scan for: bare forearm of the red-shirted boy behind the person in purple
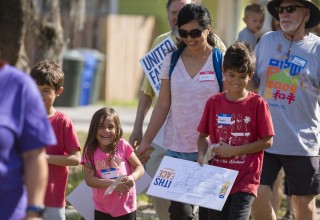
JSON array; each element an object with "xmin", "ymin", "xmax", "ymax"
[{"xmin": 47, "ymin": 148, "xmax": 81, "ymax": 166}]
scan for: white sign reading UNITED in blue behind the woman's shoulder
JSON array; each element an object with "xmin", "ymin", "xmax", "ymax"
[{"xmin": 140, "ymin": 36, "xmax": 177, "ymax": 96}]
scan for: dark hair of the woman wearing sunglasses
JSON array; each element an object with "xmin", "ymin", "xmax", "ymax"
[{"xmin": 177, "ymin": 3, "xmax": 215, "ymax": 47}]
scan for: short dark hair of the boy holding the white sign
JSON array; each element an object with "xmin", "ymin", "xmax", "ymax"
[{"xmin": 223, "ymin": 42, "xmax": 256, "ymax": 76}]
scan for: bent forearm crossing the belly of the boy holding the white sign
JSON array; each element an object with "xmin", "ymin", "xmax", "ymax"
[{"xmin": 213, "ymin": 136, "xmax": 273, "ymax": 157}]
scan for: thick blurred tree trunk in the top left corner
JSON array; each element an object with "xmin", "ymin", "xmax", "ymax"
[{"xmin": 0, "ymin": 0, "xmax": 85, "ymax": 72}]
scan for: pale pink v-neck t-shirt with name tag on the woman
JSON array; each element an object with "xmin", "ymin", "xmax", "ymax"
[{"xmin": 160, "ymin": 53, "xmax": 220, "ymax": 153}]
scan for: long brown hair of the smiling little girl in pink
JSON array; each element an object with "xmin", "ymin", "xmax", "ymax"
[{"xmin": 82, "ymin": 107, "xmax": 123, "ymax": 175}]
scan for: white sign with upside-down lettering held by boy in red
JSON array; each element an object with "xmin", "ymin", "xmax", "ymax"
[{"xmin": 147, "ymin": 156, "xmax": 238, "ymax": 211}]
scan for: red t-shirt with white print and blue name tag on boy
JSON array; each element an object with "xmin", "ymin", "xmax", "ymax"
[{"xmin": 198, "ymin": 92, "xmax": 274, "ymax": 196}]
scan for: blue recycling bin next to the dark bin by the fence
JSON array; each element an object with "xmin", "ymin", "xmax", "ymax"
[{"xmin": 77, "ymin": 48, "xmax": 105, "ymax": 105}]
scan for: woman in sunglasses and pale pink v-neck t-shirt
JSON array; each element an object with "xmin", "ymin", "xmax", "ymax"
[{"xmin": 137, "ymin": 4, "xmax": 225, "ymax": 220}]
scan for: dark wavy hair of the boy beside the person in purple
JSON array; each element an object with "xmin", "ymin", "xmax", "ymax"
[{"xmin": 30, "ymin": 59, "xmax": 64, "ymax": 92}]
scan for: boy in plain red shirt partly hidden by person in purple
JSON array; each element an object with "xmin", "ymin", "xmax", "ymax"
[{"xmin": 30, "ymin": 60, "xmax": 81, "ymax": 220}]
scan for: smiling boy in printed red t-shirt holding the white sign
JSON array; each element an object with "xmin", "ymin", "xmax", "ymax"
[{"xmin": 198, "ymin": 42, "xmax": 274, "ymax": 220}]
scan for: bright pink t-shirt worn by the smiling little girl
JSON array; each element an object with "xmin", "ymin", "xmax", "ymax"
[{"xmin": 81, "ymin": 139, "xmax": 137, "ymax": 217}]
